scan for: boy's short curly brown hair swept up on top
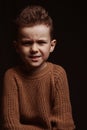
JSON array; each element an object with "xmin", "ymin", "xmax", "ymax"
[{"xmin": 15, "ymin": 5, "xmax": 53, "ymax": 39}]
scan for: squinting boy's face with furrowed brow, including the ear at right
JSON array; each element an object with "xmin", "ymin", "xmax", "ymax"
[{"xmin": 16, "ymin": 24, "xmax": 56, "ymax": 68}]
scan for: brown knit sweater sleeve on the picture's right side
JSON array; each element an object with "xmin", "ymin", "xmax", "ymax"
[{"xmin": 51, "ymin": 66, "xmax": 75, "ymax": 130}]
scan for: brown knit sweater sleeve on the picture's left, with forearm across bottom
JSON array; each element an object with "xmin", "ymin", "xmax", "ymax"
[{"xmin": 0, "ymin": 70, "xmax": 42, "ymax": 130}]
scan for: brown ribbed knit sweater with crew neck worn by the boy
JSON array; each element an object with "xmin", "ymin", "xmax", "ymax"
[{"xmin": 2, "ymin": 62, "xmax": 75, "ymax": 130}]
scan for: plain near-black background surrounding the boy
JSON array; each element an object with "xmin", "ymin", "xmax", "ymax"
[{"xmin": 0, "ymin": 0, "xmax": 87, "ymax": 130}]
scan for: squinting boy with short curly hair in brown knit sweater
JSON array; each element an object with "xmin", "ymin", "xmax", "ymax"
[{"xmin": 2, "ymin": 6, "xmax": 75, "ymax": 130}]
